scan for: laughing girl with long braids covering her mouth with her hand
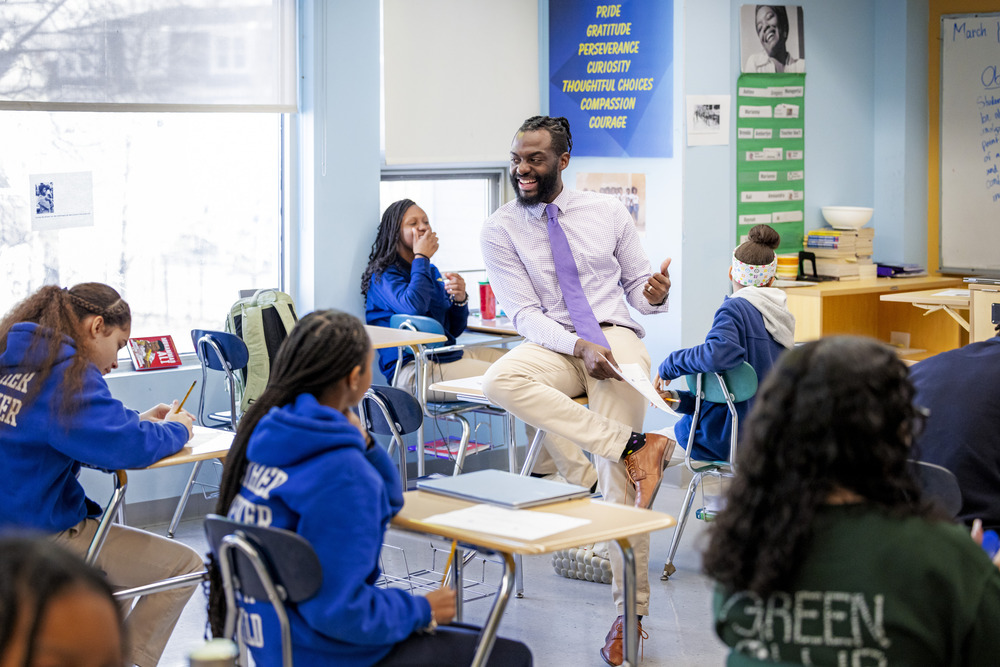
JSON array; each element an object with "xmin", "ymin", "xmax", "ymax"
[{"xmin": 361, "ymin": 199, "xmax": 506, "ymax": 401}]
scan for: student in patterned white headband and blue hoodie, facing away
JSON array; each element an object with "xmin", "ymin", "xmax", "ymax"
[{"xmin": 656, "ymin": 225, "xmax": 795, "ymax": 461}]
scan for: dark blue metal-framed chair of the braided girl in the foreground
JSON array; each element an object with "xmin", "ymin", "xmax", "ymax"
[{"xmin": 205, "ymin": 514, "xmax": 323, "ymax": 667}]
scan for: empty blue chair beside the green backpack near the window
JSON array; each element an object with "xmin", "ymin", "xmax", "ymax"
[{"xmin": 167, "ymin": 329, "xmax": 250, "ymax": 537}]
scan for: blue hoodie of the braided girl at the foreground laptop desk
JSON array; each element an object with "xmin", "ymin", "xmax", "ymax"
[{"xmin": 229, "ymin": 394, "xmax": 431, "ymax": 667}]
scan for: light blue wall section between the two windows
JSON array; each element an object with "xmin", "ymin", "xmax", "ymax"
[{"xmin": 293, "ymin": 0, "xmax": 381, "ymax": 317}]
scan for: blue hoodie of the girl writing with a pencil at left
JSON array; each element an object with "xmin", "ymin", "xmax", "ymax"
[{"xmin": 0, "ymin": 322, "xmax": 188, "ymax": 533}]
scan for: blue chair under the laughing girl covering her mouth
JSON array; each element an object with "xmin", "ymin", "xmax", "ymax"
[{"xmin": 389, "ymin": 315, "xmax": 505, "ymax": 475}]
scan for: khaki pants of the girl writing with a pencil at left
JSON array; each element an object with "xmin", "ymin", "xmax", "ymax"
[{"xmin": 53, "ymin": 519, "xmax": 205, "ymax": 667}]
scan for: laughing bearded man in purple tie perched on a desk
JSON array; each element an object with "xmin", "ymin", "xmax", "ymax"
[{"xmin": 481, "ymin": 116, "xmax": 675, "ymax": 665}]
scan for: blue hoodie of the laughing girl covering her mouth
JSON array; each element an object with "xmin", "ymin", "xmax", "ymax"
[{"xmin": 365, "ymin": 257, "xmax": 469, "ymax": 384}]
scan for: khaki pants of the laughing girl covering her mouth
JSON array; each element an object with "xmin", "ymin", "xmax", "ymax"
[{"xmin": 393, "ymin": 347, "xmax": 597, "ymax": 489}]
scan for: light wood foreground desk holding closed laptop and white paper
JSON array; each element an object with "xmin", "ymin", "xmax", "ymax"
[{"xmin": 392, "ymin": 491, "xmax": 676, "ymax": 667}]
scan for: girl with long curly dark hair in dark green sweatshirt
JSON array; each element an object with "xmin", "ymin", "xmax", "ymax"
[{"xmin": 703, "ymin": 336, "xmax": 1000, "ymax": 667}]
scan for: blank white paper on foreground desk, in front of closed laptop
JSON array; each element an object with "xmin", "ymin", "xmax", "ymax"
[{"xmin": 422, "ymin": 503, "xmax": 590, "ymax": 540}]
